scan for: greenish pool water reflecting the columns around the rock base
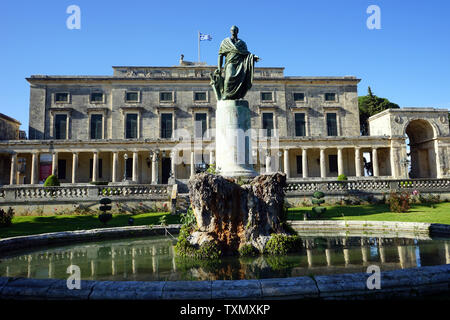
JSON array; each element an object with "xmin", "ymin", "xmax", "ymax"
[{"xmin": 0, "ymin": 236, "xmax": 450, "ymax": 281}]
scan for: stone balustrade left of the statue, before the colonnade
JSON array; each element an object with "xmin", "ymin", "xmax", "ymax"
[{"xmin": 0, "ymin": 184, "xmax": 172, "ymax": 204}]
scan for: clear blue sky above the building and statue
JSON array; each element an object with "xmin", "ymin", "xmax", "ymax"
[{"xmin": 0, "ymin": 0, "xmax": 450, "ymax": 131}]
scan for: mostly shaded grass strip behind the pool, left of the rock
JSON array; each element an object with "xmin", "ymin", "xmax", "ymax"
[{"xmin": 0, "ymin": 212, "xmax": 179, "ymax": 238}]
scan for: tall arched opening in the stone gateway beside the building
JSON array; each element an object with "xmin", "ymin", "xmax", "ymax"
[{"xmin": 404, "ymin": 119, "xmax": 438, "ymax": 178}]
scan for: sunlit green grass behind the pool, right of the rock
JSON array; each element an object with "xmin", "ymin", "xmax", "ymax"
[{"xmin": 288, "ymin": 202, "xmax": 450, "ymax": 224}]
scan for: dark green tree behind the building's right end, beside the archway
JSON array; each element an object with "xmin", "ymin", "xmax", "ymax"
[{"xmin": 358, "ymin": 87, "xmax": 400, "ymax": 136}]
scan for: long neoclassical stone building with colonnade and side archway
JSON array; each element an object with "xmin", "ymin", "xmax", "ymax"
[{"xmin": 0, "ymin": 64, "xmax": 450, "ymax": 184}]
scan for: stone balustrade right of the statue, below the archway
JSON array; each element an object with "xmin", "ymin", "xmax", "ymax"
[{"xmin": 285, "ymin": 179, "xmax": 450, "ymax": 195}]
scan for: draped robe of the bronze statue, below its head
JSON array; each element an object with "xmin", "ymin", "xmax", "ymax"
[{"xmin": 211, "ymin": 38, "xmax": 255, "ymax": 100}]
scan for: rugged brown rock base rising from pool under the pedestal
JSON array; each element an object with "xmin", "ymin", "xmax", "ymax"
[{"xmin": 188, "ymin": 173, "xmax": 286, "ymax": 255}]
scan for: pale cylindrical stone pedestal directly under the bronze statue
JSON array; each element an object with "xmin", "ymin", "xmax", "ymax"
[{"xmin": 216, "ymin": 100, "xmax": 257, "ymax": 177}]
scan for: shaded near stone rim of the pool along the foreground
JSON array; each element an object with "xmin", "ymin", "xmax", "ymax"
[{"xmin": 0, "ymin": 264, "xmax": 450, "ymax": 300}]
